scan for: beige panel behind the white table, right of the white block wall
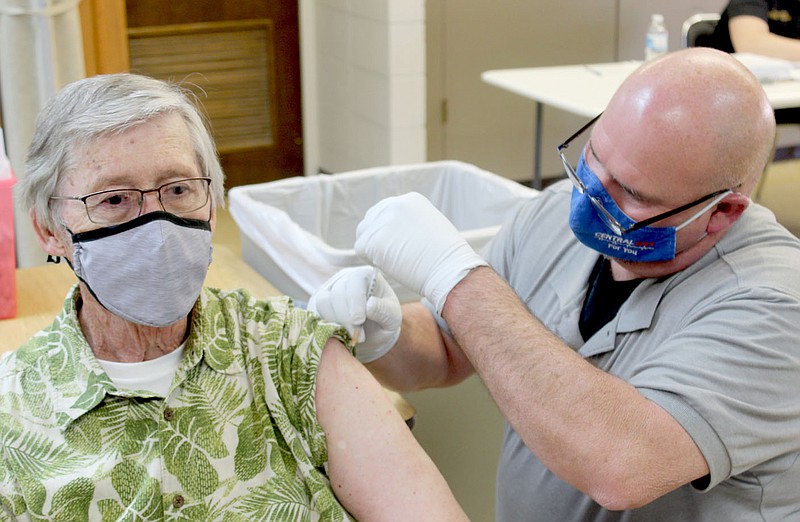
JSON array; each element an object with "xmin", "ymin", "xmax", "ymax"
[{"xmin": 426, "ymin": 0, "xmax": 617, "ymax": 181}]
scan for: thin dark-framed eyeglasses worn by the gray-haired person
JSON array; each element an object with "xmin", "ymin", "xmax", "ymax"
[{"xmin": 50, "ymin": 178, "xmax": 211, "ymax": 225}]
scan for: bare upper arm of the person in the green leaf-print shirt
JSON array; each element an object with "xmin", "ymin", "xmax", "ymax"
[{"xmin": 316, "ymin": 339, "xmax": 468, "ymax": 521}]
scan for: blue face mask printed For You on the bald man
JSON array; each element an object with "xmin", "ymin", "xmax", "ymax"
[{"xmin": 569, "ymin": 154, "xmax": 731, "ymax": 263}]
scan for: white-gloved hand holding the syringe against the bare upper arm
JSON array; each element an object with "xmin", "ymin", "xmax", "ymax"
[{"xmin": 308, "ymin": 266, "xmax": 403, "ymax": 363}]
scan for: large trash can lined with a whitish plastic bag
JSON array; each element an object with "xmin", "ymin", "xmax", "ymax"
[{"xmin": 228, "ymin": 161, "xmax": 538, "ymax": 304}]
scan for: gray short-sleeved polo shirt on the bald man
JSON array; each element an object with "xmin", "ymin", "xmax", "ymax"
[{"xmin": 487, "ymin": 182, "xmax": 800, "ymax": 522}]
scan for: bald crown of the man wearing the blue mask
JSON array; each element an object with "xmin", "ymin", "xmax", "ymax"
[{"xmin": 593, "ymin": 48, "xmax": 775, "ymax": 195}]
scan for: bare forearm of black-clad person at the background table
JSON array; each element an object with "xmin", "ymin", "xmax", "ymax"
[{"xmin": 728, "ymin": 15, "xmax": 800, "ymax": 62}]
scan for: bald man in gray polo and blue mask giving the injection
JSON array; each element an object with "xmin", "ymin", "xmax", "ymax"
[{"xmin": 312, "ymin": 48, "xmax": 800, "ymax": 522}]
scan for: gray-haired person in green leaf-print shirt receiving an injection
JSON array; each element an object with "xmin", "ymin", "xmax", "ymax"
[{"xmin": 0, "ymin": 74, "xmax": 465, "ymax": 521}]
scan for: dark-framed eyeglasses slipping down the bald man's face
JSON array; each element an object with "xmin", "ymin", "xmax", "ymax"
[{"xmin": 558, "ymin": 112, "xmax": 733, "ymax": 236}]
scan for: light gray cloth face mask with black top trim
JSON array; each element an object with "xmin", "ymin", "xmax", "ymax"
[{"xmin": 67, "ymin": 212, "xmax": 212, "ymax": 327}]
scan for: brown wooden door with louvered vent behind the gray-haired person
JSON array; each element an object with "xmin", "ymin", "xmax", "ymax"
[{"xmin": 125, "ymin": 0, "xmax": 303, "ymax": 187}]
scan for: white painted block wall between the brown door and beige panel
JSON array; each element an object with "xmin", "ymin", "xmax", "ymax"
[{"xmin": 310, "ymin": 0, "xmax": 426, "ymax": 172}]
